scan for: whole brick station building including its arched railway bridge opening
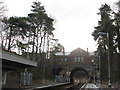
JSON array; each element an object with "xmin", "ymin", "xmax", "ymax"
[{"xmin": 55, "ymin": 48, "xmax": 98, "ymax": 82}]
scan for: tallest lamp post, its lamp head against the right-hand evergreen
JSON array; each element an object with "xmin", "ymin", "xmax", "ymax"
[{"xmin": 98, "ymin": 32, "xmax": 111, "ymax": 87}]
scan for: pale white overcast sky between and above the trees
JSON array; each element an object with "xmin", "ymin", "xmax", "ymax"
[{"xmin": 4, "ymin": 0, "xmax": 117, "ymax": 52}]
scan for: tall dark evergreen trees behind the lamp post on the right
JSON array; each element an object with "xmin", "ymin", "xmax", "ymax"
[{"xmin": 92, "ymin": 4, "xmax": 120, "ymax": 81}]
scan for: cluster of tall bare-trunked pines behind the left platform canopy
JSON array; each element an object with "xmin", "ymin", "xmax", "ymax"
[{"xmin": 2, "ymin": 1, "xmax": 63, "ymax": 60}]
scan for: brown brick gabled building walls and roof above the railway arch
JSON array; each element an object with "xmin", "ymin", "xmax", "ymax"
[{"xmin": 55, "ymin": 48, "xmax": 98, "ymax": 77}]
